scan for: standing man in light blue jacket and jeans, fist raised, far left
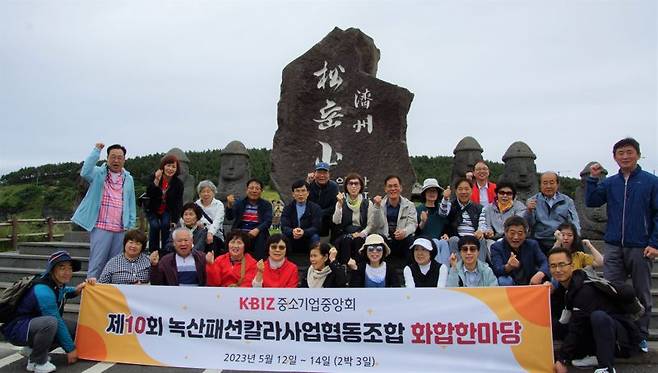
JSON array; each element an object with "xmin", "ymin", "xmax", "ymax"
[{"xmin": 71, "ymin": 143, "xmax": 137, "ymax": 278}]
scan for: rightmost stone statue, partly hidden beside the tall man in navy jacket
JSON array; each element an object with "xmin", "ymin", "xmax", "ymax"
[{"xmin": 574, "ymin": 161, "xmax": 608, "ymax": 240}]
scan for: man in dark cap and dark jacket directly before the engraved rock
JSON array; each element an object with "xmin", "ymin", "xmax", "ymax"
[{"xmin": 306, "ymin": 162, "xmax": 340, "ymax": 236}]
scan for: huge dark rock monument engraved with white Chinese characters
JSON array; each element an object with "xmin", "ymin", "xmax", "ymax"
[{"xmin": 271, "ymin": 28, "xmax": 415, "ymax": 200}]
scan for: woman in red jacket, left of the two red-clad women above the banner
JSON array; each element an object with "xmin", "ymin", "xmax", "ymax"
[{"xmin": 206, "ymin": 230, "xmax": 256, "ymax": 288}]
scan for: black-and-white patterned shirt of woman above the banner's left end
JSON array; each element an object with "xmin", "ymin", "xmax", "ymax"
[{"xmin": 98, "ymin": 254, "xmax": 151, "ymax": 285}]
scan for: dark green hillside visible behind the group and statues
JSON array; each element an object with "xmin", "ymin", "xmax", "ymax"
[{"xmin": 0, "ymin": 149, "xmax": 578, "ymax": 221}]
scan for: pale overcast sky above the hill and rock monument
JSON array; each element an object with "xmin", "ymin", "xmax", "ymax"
[{"xmin": 0, "ymin": 0, "xmax": 658, "ymax": 176}]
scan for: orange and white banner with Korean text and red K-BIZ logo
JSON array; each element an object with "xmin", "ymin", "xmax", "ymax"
[{"xmin": 76, "ymin": 285, "xmax": 553, "ymax": 372}]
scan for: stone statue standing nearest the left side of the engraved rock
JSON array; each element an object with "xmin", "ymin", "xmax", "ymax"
[{"xmin": 216, "ymin": 141, "xmax": 251, "ymax": 203}]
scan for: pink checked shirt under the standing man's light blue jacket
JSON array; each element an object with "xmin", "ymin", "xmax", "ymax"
[{"xmin": 96, "ymin": 172, "xmax": 123, "ymax": 232}]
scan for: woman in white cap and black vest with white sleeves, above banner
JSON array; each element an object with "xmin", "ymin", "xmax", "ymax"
[{"xmin": 403, "ymin": 237, "xmax": 448, "ymax": 288}]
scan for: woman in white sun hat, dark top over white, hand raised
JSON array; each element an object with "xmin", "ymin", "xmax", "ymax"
[{"xmin": 347, "ymin": 234, "xmax": 400, "ymax": 288}]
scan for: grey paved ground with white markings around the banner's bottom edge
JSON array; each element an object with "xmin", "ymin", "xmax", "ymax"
[{"xmin": 0, "ymin": 342, "xmax": 658, "ymax": 373}]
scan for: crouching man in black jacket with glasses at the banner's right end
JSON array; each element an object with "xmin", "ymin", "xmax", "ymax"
[{"xmin": 548, "ymin": 248, "xmax": 640, "ymax": 373}]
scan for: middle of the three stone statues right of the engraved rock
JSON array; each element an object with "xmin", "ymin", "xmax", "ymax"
[{"xmin": 498, "ymin": 141, "xmax": 539, "ymax": 204}]
